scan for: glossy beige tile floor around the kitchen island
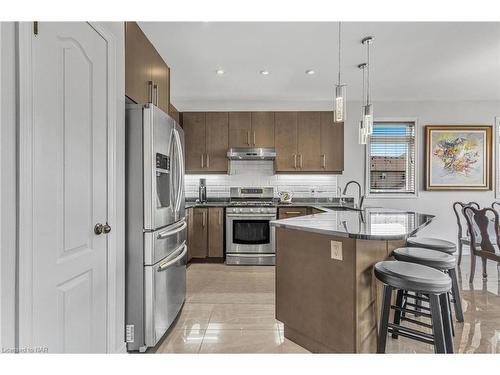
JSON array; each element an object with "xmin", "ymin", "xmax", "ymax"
[{"xmin": 152, "ymin": 257, "xmax": 500, "ymax": 353}]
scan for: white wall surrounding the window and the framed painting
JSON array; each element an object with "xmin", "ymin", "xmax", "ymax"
[{"xmin": 339, "ymin": 101, "xmax": 500, "ymax": 247}]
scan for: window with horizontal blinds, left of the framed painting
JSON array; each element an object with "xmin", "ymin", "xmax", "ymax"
[{"xmin": 367, "ymin": 121, "xmax": 416, "ymax": 197}]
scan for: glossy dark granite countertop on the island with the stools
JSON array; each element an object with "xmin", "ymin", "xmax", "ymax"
[{"xmin": 271, "ymin": 209, "xmax": 434, "ymax": 240}]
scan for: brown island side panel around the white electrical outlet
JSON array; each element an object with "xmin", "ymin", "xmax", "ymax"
[{"xmin": 276, "ymin": 228, "xmax": 356, "ymax": 353}]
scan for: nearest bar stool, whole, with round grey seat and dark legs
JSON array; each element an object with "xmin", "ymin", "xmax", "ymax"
[{"xmin": 374, "ymin": 261, "xmax": 453, "ymax": 353}]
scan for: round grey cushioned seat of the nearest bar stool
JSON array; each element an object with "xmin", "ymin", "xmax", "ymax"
[{"xmin": 375, "ymin": 261, "xmax": 451, "ymax": 294}]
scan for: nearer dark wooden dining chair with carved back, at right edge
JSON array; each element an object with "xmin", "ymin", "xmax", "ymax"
[{"xmin": 463, "ymin": 206, "xmax": 500, "ymax": 284}]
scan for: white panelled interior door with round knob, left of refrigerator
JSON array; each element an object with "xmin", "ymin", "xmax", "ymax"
[{"xmin": 20, "ymin": 22, "xmax": 108, "ymax": 353}]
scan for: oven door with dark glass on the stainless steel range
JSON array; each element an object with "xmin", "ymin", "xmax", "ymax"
[{"xmin": 226, "ymin": 213, "xmax": 276, "ymax": 253}]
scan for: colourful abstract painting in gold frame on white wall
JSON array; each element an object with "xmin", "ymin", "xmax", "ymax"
[{"xmin": 426, "ymin": 125, "xmax": 491, "ymax": 190}]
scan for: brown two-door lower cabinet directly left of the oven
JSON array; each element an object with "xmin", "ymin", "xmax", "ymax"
[{"xmin": 188, "ymin": 207, "xmax": 224, "ymax": 260}]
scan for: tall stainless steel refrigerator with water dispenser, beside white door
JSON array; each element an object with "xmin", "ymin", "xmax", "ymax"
[{"xmin": 125, "ymin": 104, "xmax": 187, "ymax": 351}]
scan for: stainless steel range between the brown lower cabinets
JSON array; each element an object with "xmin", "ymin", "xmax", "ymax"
[{"xmin": 226, "ymin": 187, "xmax": 277, "ymax": 265}]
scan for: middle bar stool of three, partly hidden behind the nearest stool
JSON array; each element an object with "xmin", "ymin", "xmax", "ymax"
[{"xmin": 392, "ymin": 247, "xmax": 464, "ymax": 322}]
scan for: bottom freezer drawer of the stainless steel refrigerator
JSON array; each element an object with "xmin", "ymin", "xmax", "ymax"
[{"xmin": 144, "ymin": 244, "xmax": 187, "ymax": 346}]
